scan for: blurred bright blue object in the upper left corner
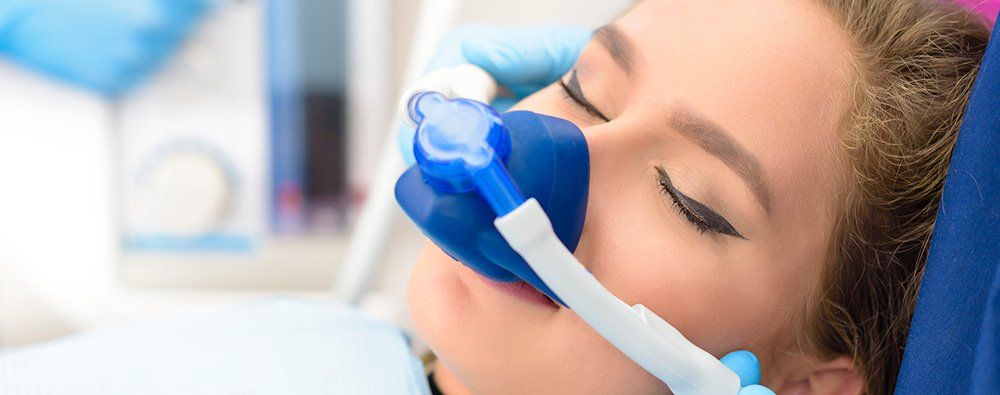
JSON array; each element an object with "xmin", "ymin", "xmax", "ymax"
[{"xmin": 0, "ymin": 0, "xmax": 214, "ymax": 96}]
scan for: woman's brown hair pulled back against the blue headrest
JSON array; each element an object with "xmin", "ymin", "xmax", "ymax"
[{"xmin": 803, "ymin": 0, "xmax": 989, "ymax": 394}]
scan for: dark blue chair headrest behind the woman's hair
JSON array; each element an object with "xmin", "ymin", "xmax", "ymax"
[{"xmin": 896, "ymin": 20, "xmax": 1000, "ymax": 394}]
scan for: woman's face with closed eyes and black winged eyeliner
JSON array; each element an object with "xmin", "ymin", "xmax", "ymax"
[{"xmin": 409, "ymin": 0, "xmax": 850, "ymax": 393}]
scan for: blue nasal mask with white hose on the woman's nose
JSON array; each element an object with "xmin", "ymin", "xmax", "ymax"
[{"xmin": 396, "ymin": 69, "xmax": 766, "ymax": 394}]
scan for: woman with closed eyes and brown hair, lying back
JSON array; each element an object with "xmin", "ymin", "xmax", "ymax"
[{"xmin": 409, "ymin": 0, "xmax": 988, "ymax": 394}]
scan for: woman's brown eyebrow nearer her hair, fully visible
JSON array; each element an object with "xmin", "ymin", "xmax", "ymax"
[{"xmin": 670, "ymin": 106, "xmax": 771, "ymax": 214}]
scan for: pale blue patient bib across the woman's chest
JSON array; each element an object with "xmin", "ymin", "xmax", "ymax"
[{"xmin": 0, "ymin": 298, "xmax": 430, "ymax": 395}]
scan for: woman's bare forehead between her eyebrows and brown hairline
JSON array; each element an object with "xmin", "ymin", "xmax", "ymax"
[{"xmin": 615, "ymin": 0, "xmax": 852, "ymax": 223}]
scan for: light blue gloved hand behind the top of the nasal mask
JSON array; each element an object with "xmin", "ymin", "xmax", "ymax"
[{"xmin": 398, "ymin": 26, "xmax": 592, "ymax": 165}]
